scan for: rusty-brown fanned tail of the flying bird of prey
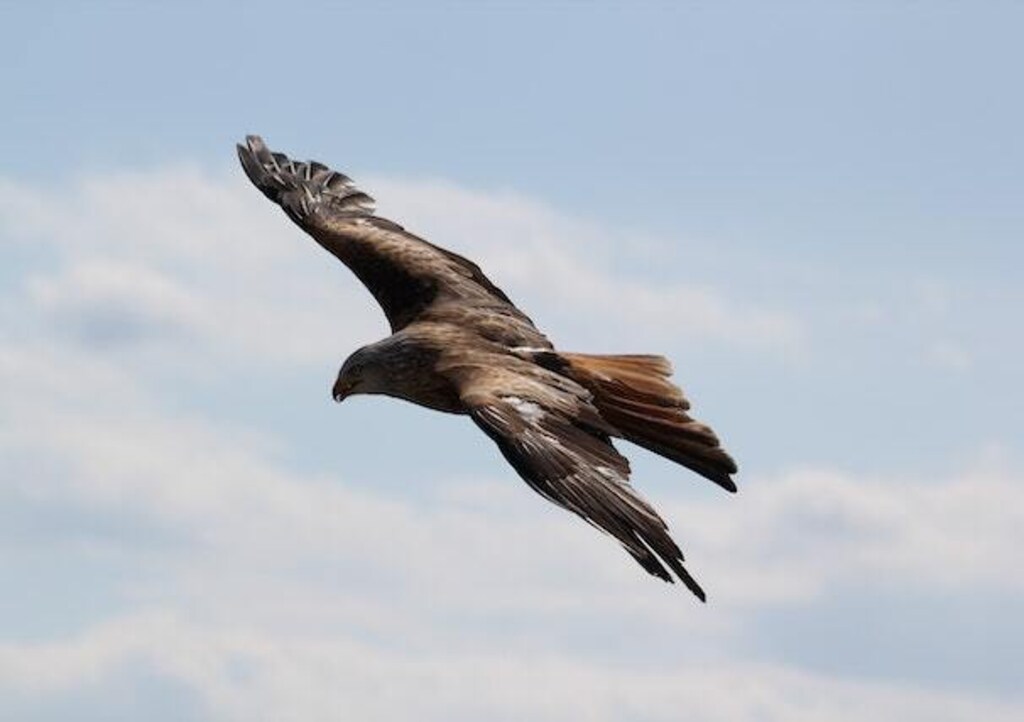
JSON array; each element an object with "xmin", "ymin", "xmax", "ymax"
[{"xmin": 557, "ymin": 353, "xmax": 736, "ymax": 492}]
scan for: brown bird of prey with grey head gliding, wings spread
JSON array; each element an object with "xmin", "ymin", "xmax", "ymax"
[{"xmin": 237, "ymin": 135, "xmax": 737, "ymax": 601}]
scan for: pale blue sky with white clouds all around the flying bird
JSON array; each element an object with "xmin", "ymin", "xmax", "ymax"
[{"xmin": 0, "ymin": 0, "xmax": 1024, "ymax": 722}]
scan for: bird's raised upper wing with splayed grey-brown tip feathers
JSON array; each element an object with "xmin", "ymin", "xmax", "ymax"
[{"xmin": 238, "ymin": 135, "xmax": 539, "ymax": 341}]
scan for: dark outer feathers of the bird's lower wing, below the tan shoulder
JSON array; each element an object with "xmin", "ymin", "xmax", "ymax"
[{"xmin": 464, "ymin": 394, "xmax": 705, "ymax": 601}]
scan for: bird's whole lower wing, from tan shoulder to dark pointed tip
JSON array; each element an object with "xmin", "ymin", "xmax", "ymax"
[{"xmin": 449, "ymin": 365, "xmax": 705, "ymax": 601}]
